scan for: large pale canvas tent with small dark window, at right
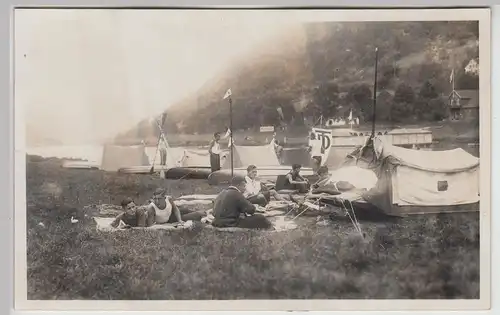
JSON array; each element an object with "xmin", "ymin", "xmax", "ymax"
[{"xmin": 350, "ymin": 138, "xmax": 479, "ymax": 216}]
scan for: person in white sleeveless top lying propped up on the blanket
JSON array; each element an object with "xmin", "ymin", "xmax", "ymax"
[{"xmin": 147, "ymin": 188, "xmax": 205, "ymax": 224}]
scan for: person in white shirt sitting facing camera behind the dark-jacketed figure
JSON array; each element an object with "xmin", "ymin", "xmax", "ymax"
[{"xmin": 243, "ymin": 165, "xmax": 285, "ymax": 207}]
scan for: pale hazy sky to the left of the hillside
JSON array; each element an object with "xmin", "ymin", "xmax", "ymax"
[{"xmin": 14, "ymin": 9, "xmax": 291, "ymax": 142}]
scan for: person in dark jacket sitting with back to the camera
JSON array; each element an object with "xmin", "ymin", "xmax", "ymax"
[{"xmin": 212, "ymin": 177, "xmax": 272, "ymax": 229}]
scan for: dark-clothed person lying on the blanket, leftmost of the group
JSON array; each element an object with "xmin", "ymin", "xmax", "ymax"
[{"xmin": 111, "ymin": 198, "xmax": 155, "ymax": 228}]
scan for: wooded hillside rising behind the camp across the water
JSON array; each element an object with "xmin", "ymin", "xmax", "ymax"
[{"xmin": 116, "ymin": 22, "xmax": 479, "ymax": 145}]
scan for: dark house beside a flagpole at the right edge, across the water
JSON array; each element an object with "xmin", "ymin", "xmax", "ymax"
[{"xmin": 448, "ymin": 90, "xmax": 479, "ymax": 120}]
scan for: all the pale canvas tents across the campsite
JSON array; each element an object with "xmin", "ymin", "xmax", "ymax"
[{"xmin": 75, "ymin": 133, "xmax": 480, "ymax": 216}]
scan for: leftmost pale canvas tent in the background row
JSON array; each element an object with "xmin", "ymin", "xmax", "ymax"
[{"xmin": 101, "ymin": 145, "xmax": 149, "ymax": 172}]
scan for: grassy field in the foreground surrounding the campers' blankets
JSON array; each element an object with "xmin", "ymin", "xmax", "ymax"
[{"xmin": 27, "ymin": 158, "xmax": 479, "ymax": 300}]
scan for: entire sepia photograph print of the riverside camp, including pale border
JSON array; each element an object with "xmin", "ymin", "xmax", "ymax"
[{"xmin": 13, "ymin": 8, "xmax": 490, "ymax": 307}]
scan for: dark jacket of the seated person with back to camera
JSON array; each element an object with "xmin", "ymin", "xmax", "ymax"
[{"xmin": 212, "ymin": 187, "xmax": 255, "ymax": 227}]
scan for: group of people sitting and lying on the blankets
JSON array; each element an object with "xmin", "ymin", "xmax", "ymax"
[{"xmin": 111, "ymin": 164, "xmax": 336, "ymax": 229}]
